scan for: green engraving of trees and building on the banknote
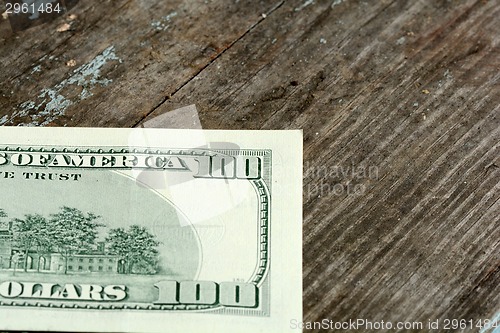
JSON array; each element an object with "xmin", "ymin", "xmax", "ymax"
[{"xmin": 0, "ymin": 207, "xmax": 159, "ymax": 275}]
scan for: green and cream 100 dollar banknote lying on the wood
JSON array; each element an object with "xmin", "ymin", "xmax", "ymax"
[{"xmin": 0, "ymin": 127, "xmax": 302, "ymax": 332}]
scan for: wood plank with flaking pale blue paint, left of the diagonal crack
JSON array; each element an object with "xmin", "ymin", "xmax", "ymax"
[{"xmin": 0, "ymin": 1, "xmax": 280, "ymax": 126}]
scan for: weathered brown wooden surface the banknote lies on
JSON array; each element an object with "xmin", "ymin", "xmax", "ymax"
[{"xmin": 0, "ymin": 0, "xmax": 500, "ymax": 331}]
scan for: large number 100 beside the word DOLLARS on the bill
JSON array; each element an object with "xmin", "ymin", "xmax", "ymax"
[{"xmin": 154, "ymin": 281, "xmax": 259, "ymax": 308}]
